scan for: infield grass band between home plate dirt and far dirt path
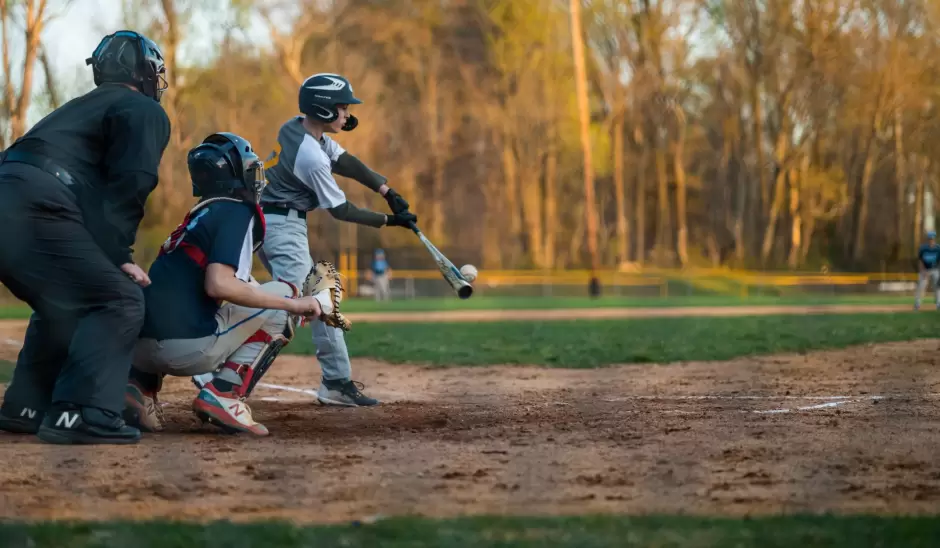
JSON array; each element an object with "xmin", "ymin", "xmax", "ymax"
[{"xmin": 285, "ymin": 313, "xmax": 940, "ymax": 368}]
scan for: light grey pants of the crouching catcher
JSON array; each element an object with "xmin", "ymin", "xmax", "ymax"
[{"xmin": 134, "ymin": 282, "xmax": 294, "ymax": 377}]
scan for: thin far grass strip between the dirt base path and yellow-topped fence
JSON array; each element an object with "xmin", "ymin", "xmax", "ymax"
[{"xmin": 0, "ymin": 295, "xmax": 916, "ymax": 320}]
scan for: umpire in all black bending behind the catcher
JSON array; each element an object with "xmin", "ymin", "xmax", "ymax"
[{"xmin": 0, "ymin": 31, "xmax": 170, "ymax": 444}]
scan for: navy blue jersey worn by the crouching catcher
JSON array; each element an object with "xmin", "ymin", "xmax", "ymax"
[{"xmin": 140, "ymin": 201, "xmax": 256, "ymax": 340}]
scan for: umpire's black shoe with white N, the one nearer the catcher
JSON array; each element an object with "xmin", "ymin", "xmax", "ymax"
[{"xmin": 38, "ymin": 404, "xmax": 140, "ymax": 445}]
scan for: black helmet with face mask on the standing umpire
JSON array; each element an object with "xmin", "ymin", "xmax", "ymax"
[{"xmin": 85, "ymin": 30, "xmax": 167, "ymax": 103}]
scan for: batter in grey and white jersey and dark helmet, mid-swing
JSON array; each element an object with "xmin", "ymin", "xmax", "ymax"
[{"xmin": 193, "ymin": 74, "xmax": 417, "ymax": 407}]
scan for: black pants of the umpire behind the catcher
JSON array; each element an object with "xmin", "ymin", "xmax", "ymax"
[{"xmin": 0, "ymin": 162, "xmax": 144, "ymax": 413}]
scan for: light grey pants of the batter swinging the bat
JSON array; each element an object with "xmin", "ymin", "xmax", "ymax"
[{"xmin": 258, "ymin": 211, "xmax": 352, "ymax": 380}]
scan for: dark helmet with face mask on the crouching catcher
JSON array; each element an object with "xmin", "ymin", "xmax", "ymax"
[{"xmin": 186, "ymin": 133, "xmax": 267, "ymax": 203}]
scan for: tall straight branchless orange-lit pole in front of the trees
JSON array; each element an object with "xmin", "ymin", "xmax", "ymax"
[{"xmin": 568, "ymin": 0, "xmax": 600, "ymax": 275}]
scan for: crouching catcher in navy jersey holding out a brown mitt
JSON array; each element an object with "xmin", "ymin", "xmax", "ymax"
[{"xmin": 124, "ymin": 133, "xmax": 348, "ymax": 436}]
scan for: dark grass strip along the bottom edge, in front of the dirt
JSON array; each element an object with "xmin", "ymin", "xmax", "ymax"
[{"xmin": 0, "ymin": 516, "xmax": 940, "ymax": 548}]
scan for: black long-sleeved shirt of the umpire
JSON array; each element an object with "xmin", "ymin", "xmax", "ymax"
[{"xmin": 10, "ymin": 84, "xmax": 170, "ymax": 265}]
